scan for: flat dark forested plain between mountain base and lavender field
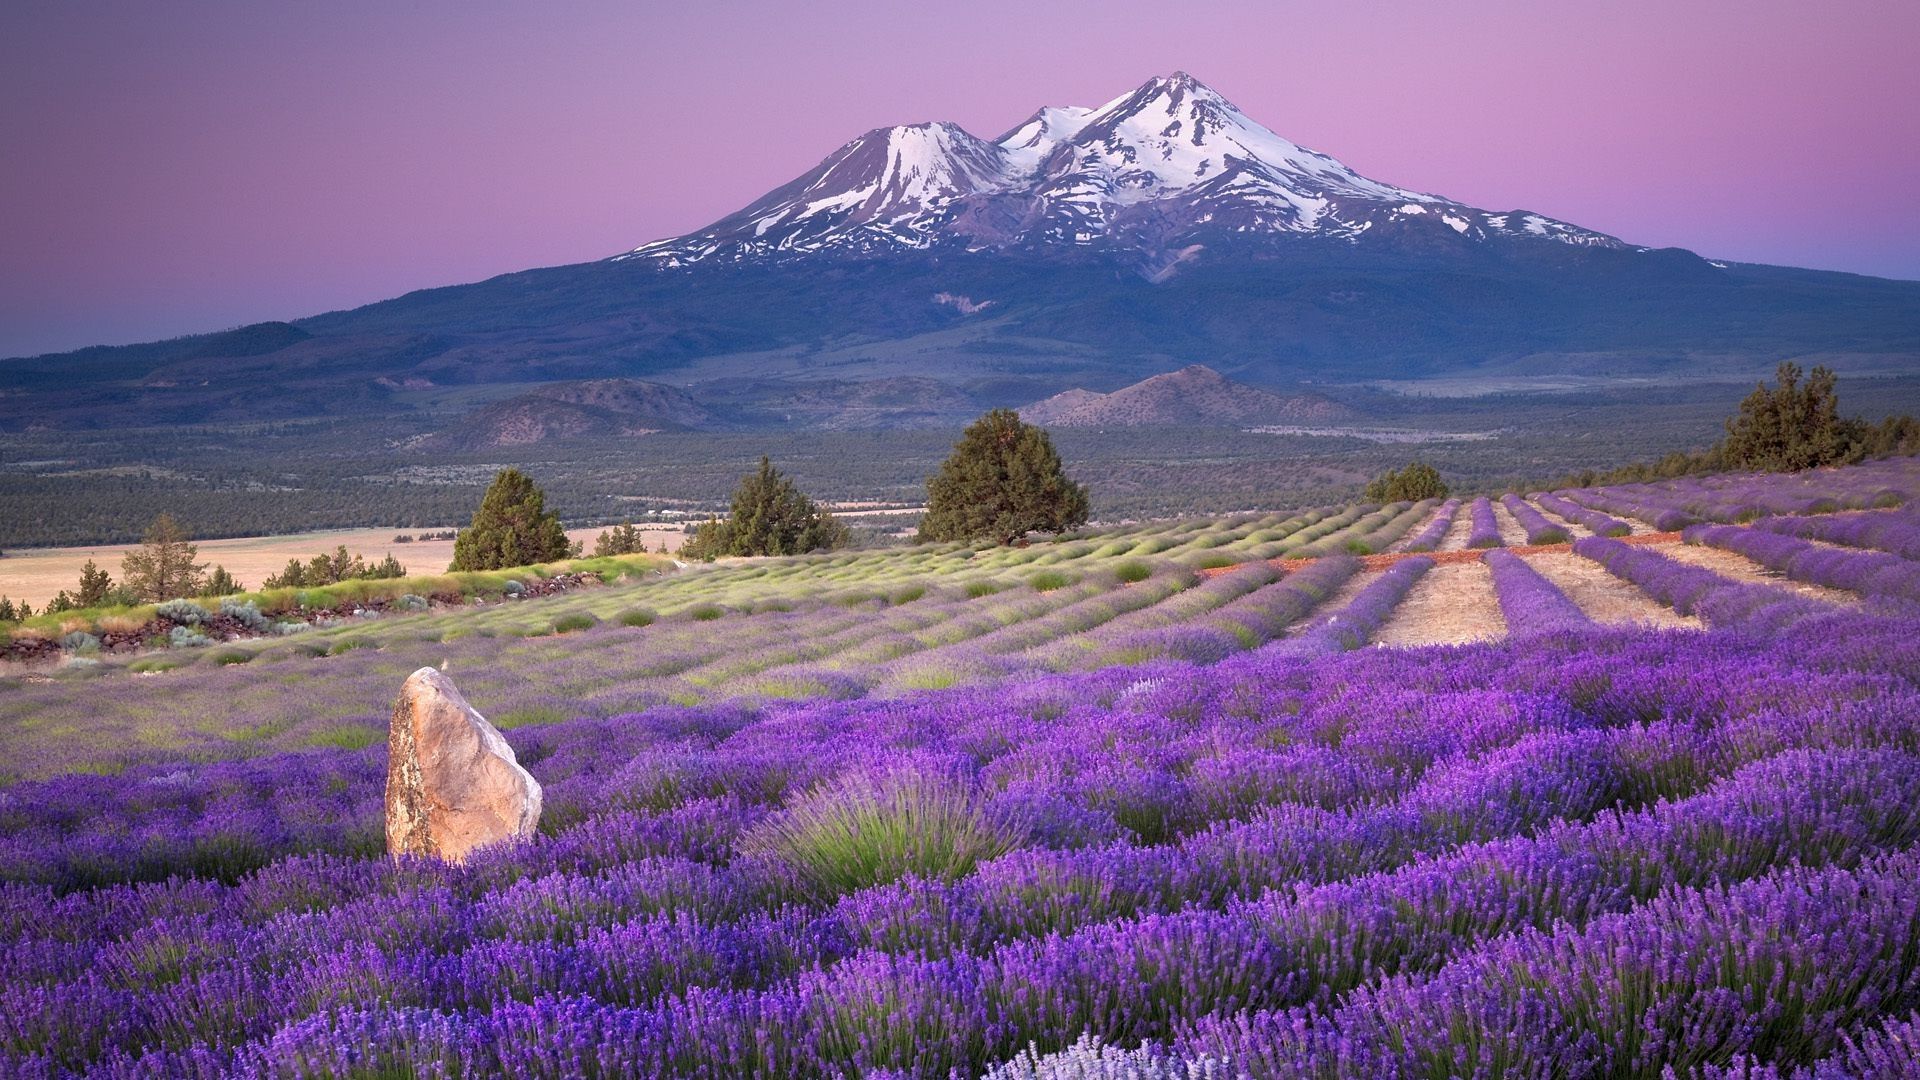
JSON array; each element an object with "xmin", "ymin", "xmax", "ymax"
[{"xmin": 0, "ymin": 379, "xmax": 1920, "ymax": 550}]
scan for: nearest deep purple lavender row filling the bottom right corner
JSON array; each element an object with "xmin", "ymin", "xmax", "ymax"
[{"xmin": 1183, "ymin": 853, "xmax": 1920, "ymax": 1076}]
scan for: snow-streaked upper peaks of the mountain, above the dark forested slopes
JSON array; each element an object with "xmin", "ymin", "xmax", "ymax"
[{"xmin": 618, "ymin": 71, "xmax": 1624, "ymax": 273}]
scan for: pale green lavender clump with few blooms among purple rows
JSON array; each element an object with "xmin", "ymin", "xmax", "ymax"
[{"xmin": 743, "ymin": 769, "xmax": 1027, "ymax": 901}]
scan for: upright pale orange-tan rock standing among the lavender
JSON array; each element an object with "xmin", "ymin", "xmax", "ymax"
[{"xmin": 386, "ymin": 667, "xmax": 540, "ymax": 863}]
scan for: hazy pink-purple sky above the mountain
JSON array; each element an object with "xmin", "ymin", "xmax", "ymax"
[{"xmin": 0, "ymin": 0, "xmax": 1920, "ymax": 356}]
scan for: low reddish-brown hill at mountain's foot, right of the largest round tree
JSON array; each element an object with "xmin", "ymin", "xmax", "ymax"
[{"xmin": 1020, "ymin": 363, "xmax": 1352, "ymax": 427}]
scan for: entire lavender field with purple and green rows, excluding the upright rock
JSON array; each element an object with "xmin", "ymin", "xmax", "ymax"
[{"xmin": 0, "ymin": 459, "xmax": 1920, "ymax": 1080}]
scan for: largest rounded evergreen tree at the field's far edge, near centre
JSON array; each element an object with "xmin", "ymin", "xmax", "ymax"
[{"xmin": 920, "ymin": 409, "xmax": 1087, "ymax": 544}]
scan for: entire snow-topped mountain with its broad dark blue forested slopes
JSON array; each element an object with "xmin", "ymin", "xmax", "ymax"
[{"xmin": 0, "ymin": 75, "xmax": 1920, "ymax": 430}]
